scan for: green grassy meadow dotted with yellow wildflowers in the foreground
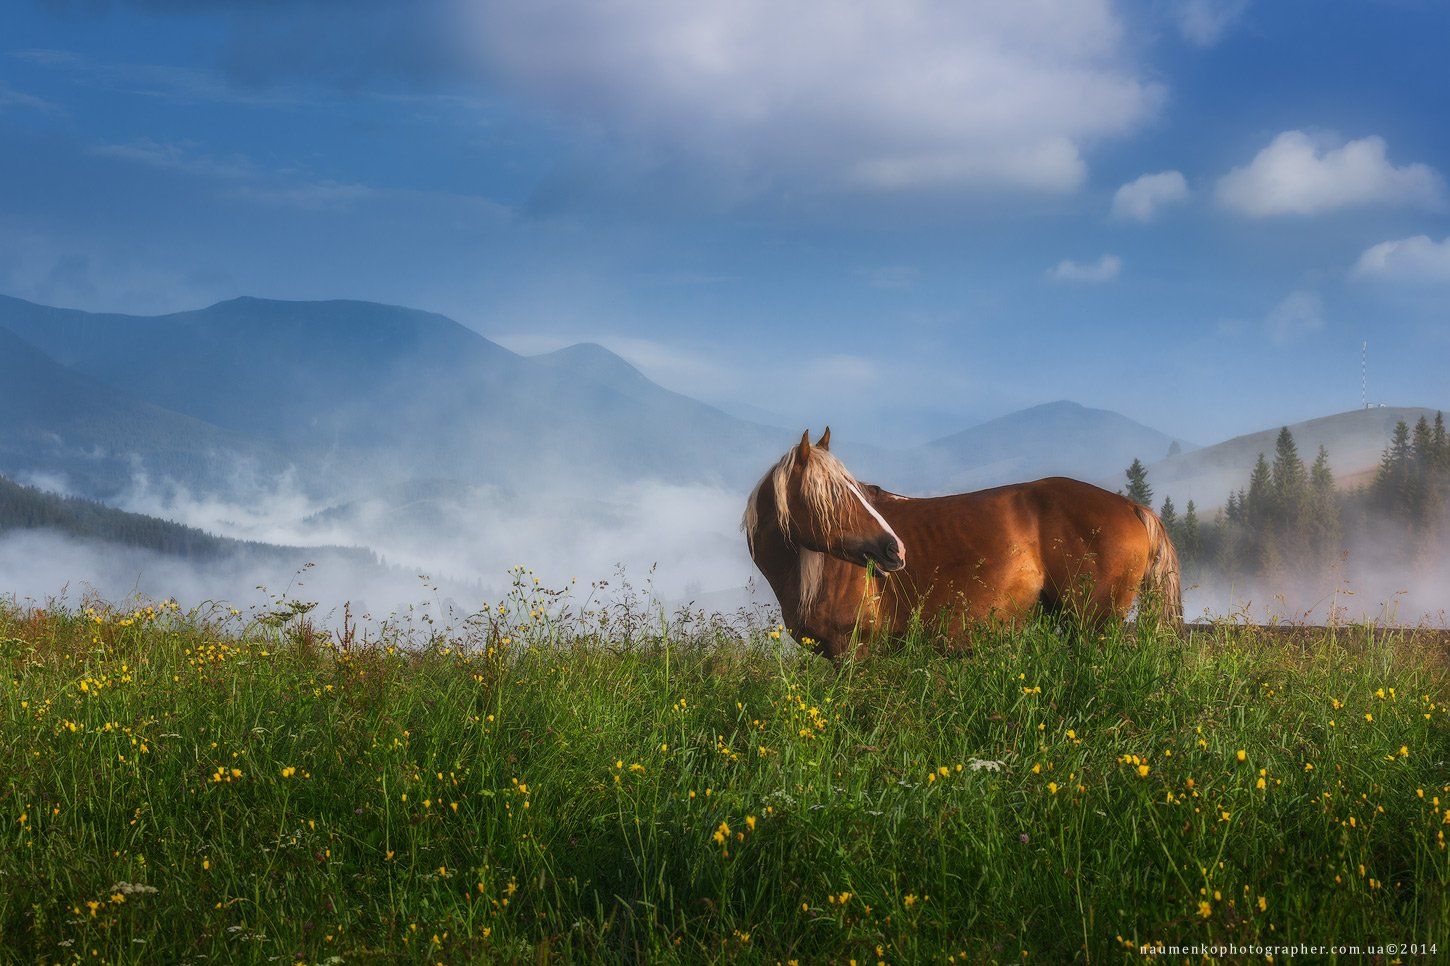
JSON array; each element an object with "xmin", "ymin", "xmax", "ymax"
[{"xmin": 0, "ymin": 579, "xmax": 1450, "ymax": 963}]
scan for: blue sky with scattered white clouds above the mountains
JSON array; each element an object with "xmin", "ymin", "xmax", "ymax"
[{"xmin": 0, "ymin": 0, "xmax": 1450, "ymax": 442}]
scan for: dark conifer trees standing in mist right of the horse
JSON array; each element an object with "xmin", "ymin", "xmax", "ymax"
[{"xmin": 1122, "ymin": 413, "xmax": 1450, "ymax": 580}]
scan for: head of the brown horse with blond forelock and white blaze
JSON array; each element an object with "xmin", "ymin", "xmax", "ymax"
[{"xmin": 745, "ymin": 429, "xmax": 906, "ymax": 571}]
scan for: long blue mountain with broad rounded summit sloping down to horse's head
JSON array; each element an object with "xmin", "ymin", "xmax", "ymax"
[{"xmin": 0, "ymin": 292, "xmax": 789, "ymax": 487}]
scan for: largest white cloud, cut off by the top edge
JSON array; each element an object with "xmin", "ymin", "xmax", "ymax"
[{"xmin": 470, "ymin": 0, "xmax": 1163, "ymax": 191}]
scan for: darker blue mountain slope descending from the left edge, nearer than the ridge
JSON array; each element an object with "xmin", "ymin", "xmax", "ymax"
[{"xmin": 0, "ymin": 328, "xmax": 287, "ymax": 496}]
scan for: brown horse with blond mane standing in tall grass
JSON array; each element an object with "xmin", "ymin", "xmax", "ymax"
[{"xmin": 744, "ymin": 429, "xmax": 1183, "ymax": 659}]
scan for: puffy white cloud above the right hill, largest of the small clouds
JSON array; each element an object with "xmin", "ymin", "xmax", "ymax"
[{"xmin": 1218, "ymin": 131, "xmax": 1444, "ymax": 218}]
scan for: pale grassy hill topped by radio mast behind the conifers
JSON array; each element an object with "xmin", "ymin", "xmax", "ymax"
[{"xmin": 1099, "ymin": 406, "xmax": 1436, "ymax": 513}]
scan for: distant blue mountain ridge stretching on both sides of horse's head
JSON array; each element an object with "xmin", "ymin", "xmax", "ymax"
[{"xmin": 0, "ymin": 290, "xmax": 1305, "ymax": 502}]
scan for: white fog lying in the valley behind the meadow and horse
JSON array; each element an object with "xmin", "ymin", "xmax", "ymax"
[{"xmin": 0, "ymin": 455, "xmax": 1450, "ymax": 627}]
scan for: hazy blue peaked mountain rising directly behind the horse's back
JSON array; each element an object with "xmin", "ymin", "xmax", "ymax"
[{"xmin": 883, "ymin": 400, "xmax": 1193, "ymax": 492}]
